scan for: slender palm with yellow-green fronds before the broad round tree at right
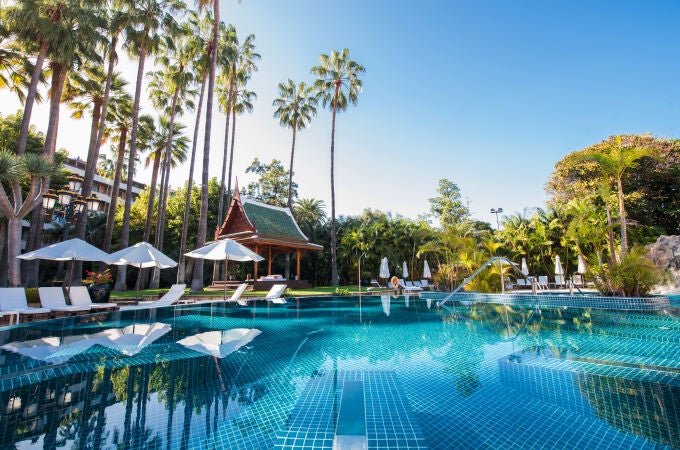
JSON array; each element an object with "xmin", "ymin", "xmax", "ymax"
[{"xmin": 579, "ymin": 136, "xmax": 656, "ymax": 260}]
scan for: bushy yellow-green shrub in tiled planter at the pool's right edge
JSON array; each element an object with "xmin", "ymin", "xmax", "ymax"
[{"xmin": 589, "ymin": 247, "xmax": 663, "ymax": 297}]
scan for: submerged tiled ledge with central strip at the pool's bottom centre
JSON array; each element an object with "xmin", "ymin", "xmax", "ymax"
[{"xmin": 274, "ymin": 371, "xmax": 427, "ymax": 450}]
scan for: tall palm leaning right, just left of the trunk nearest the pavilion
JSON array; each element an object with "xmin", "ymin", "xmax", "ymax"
[{"xmin": 177, "ymin": 12, "xmax": 213, "ymax": 283}]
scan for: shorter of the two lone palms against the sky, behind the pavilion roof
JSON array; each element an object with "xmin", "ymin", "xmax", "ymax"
[{"xmin": 273, "ymin": 78, "xmax": 318, "ymax": 208}]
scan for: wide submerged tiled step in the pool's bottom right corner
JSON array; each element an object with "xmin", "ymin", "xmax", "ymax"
[{"xmin": 498, "ymin": 354, "xmax": 680, "ymax": 447}]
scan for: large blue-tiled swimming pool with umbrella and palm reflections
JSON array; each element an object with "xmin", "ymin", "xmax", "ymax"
[{"xmin": 0, "ymin": 296, "xmax": 680, "ymax": 449}]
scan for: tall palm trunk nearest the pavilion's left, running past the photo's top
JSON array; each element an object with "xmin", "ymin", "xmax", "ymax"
[{"xmin": 191, "ymin": 5, "xmax": 220, "ymax": 291}]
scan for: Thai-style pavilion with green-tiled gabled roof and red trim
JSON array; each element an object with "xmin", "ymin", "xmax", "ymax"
[{"xmin": 215, "ymin": 184, "xmax": 323, "ymax": 290}]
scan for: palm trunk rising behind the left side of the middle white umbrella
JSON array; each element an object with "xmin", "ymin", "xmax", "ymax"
[{"xmin": 114, "ymin": 47, "xmax": 146, "ymax": 291}]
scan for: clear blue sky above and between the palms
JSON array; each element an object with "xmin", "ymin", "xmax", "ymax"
[{"xmin": 2, "ymin": 0, "xmax": 680, "ymax": 225}]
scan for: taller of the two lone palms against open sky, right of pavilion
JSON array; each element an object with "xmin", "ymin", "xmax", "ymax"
[{"xmin": 312, "ymin": 48, "xmax": 366, "ymax": 286}]
